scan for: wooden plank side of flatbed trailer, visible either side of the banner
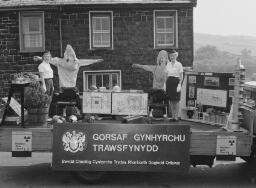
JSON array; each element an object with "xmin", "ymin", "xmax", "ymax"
[{"xmin": 0, "ymin": 120, "xmax": 253, "ymax": 157}]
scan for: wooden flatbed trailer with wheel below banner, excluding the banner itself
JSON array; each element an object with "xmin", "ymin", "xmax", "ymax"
[{"xmin": 0, "ymin": 107, "xmax": 256, "ymax": 182}]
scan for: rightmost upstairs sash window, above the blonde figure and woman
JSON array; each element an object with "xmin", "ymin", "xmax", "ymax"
[{"xmin": 154, "ymin": 11, "xmax": 178, "ymax": 48}]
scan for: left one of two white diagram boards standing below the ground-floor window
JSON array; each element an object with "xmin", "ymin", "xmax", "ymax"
[{"xmin": 83, "ymin": 91, "xmax": 111, "ymax": 114}]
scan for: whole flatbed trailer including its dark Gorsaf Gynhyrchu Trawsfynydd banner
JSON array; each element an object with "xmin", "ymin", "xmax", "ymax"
[{"xmin": 0, "ymin": 68, "xmax": 256, "ymax": 181}]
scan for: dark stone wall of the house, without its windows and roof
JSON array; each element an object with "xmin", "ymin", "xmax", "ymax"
[{"xmin": 0, "ymin": 5, "xmax": 193, "ymax": 97}]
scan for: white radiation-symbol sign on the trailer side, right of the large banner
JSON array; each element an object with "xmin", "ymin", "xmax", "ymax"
[{"xmin": 216, "ymin": 135, "xmax": 236, "ymax": 155}]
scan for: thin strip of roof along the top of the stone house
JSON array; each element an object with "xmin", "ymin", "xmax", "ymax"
[{"xmin": 0, "ymin": 0, "xmax": 197, "ymax": 9}]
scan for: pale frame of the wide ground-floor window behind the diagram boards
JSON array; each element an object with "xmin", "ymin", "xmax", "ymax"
[{"xmin": 83, "ymin": 70, "xmax": 122, "ymax": 91}]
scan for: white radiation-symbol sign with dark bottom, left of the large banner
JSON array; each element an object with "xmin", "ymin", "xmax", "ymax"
[{"xmin": 12, "ymin": 131, "xmax": 32, "ymax": 157}]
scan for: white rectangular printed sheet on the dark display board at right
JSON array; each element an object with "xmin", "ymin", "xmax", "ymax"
[{"xmin": 197, "ymin": 88, "xmax": 227, "ymax": 107}]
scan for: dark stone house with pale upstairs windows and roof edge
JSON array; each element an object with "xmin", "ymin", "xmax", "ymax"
[{"xmin": 0, "ymin": 0, "xmax": 196, "ymax": 97}]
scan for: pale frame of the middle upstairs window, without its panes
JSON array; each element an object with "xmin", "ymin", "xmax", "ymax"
[{"xmin": 89, "ymin": 11, "xmax": 114, "ymax": 50}]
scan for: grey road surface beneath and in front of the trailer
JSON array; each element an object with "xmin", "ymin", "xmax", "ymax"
[{"xmin": 0, "ymin": 152, "xmax": 256, "ymax": 188}]
